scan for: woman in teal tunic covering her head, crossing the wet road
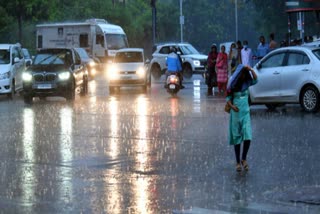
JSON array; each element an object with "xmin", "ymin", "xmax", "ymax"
[{"xmin": 226, "ymin": 64, "xmax": 257, "ymax": 172}]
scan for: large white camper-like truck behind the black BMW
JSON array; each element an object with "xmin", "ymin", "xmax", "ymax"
[{"xmin": 36, "ymin": 19, "xmax": 129, "ymax": 63}]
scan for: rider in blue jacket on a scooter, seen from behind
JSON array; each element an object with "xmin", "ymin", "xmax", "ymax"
[{"xmin": 165, "ymin": 47, "xmax": 185, "ymax": 89}]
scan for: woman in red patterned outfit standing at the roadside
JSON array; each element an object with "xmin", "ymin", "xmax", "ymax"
[{"xmin": 216, "ymin": 45, "xmax": 228, "ymax": 96}]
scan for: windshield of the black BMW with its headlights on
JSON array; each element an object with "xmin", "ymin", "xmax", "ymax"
[{"xmin": 34, "ymin": 50, "xmax": 72, "ymax": 66}]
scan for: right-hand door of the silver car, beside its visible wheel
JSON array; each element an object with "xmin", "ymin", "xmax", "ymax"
[{"xmin": 280, "ymin": 51, "xmax": 311, "ymax": 102}]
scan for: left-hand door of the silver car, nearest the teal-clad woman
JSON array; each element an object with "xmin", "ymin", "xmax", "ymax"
[{"xmin": 250, "ymin": 51, "xmax": 286, "ymax": 102}]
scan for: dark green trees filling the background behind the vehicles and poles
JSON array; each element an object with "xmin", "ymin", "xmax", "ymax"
[{"xmin": 0, "ymin": 0, "xmax": 320, "ymax": 53}]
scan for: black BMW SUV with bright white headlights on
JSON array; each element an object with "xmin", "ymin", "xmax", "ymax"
[{"xmin": 22, "ymin": 48, "xmax": 88, "ymax": 104}]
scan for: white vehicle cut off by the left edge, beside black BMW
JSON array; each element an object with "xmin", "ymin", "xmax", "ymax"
[{"xmin": 0, "ymin": 43, "xmax": 26, "ymax": 99}]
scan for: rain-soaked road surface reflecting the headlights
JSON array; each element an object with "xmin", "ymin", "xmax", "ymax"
[{"xmin": 0, "ymin": 73, "xmax": 320, "ymax": 214}]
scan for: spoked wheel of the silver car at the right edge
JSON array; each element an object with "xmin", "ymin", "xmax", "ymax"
[{"xmin": 300, "ymin": 86, "xmax": 319, "ymax": 112}]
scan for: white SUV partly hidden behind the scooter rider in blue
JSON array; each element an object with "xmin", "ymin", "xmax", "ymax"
[{"xmin": 150, "ymin": 43, "xmax": 207, "ymax": 79}]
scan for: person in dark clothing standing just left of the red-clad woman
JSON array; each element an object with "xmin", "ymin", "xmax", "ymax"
[{"xmin": 206, "ymin": 44, "xmax": 218, "ymax": 96}]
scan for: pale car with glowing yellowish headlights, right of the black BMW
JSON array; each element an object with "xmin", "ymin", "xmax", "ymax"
[{"xmin": 107, "ymin": 48, "xmax": 151, "ymax": 93}]
